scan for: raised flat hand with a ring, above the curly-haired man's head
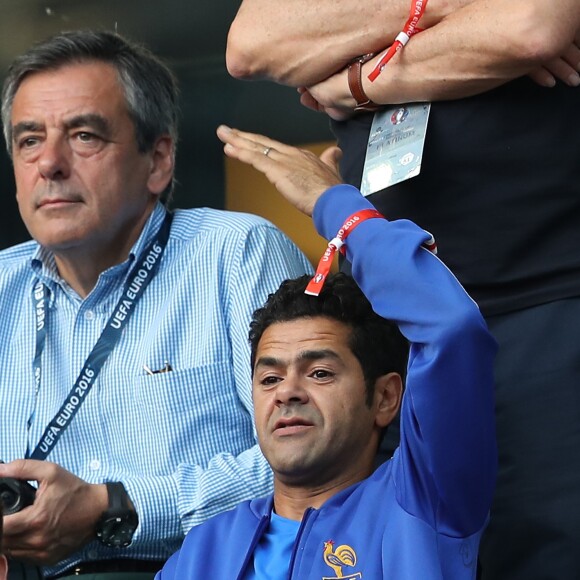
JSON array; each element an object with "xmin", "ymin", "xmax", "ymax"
[{"xmin": 217, "ymin": 125, "xmax": 342, "ymax": 216}]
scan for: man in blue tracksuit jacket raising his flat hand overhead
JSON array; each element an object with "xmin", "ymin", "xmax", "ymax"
[{"xmin": 157, "ymin": 127, "xmax": 497, "ymax": 580}]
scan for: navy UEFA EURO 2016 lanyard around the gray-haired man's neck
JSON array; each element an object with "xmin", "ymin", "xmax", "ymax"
[{"xmin": 30, "ymin": 212, "xmax": 173, "ymax": 460}]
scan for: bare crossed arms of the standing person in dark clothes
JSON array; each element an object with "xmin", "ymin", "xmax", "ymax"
[{"xmin": 227, "ymin": 0, "xmax": 580, "ymax": 118}]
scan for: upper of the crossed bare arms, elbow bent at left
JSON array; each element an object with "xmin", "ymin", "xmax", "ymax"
[{"xmin": 226, "ymin": 0, "xmax": 472, "ymax": 86}]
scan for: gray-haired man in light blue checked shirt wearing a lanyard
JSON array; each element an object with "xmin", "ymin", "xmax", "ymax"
[{"xmin": 0, "ymin": 31, "xmax": 310, "ymax": 580}]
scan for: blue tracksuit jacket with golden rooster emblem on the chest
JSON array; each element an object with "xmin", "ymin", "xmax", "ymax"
[{"xmin": 157, "ymin": 185, "xmax": 497, "ymax": 580}]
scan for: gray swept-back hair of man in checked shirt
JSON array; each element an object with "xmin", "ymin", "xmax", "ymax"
[{"xmin": 2, "ymin": 30, "xmax": 178, "ymax": 199}]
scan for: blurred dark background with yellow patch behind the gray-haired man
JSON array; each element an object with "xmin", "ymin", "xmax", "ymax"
[{"xmin": 0, "ymin": 0, "xmax": 332, "ymax": 261}]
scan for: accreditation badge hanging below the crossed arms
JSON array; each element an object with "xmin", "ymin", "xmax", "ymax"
[{"xmin": 361, "ymin": 103, "xmax": 431, "ymax": 196}]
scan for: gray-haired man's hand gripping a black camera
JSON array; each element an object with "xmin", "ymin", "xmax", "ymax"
[{"xmin": 0, "ymin": 459, "xmax": 108, "ymax": 565}]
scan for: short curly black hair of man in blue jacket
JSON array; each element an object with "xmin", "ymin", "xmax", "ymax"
[{"xmin": 249, "ymin": 273, "xmax": 409, "ymax": 405}]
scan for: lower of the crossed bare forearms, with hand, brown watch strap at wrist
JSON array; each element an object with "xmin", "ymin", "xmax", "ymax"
[{"xmin": 301, "ymin": 0, "xmax": 580, "ymax": 119}]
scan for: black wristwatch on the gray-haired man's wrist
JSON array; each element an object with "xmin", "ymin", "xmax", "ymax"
[{"xmin": 96, "ymin": 481, "xmax": 139, "ymax": 548}]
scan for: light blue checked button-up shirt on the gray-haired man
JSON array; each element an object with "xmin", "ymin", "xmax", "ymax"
[{"xmin": 0, "ymin": 205, "xmax": 311, "ymax": 574}]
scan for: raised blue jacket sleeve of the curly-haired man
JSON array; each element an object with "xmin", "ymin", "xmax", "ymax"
[{"xmin": 314, "ymin": 185, "xmax": 497, "ymax": 536}]
